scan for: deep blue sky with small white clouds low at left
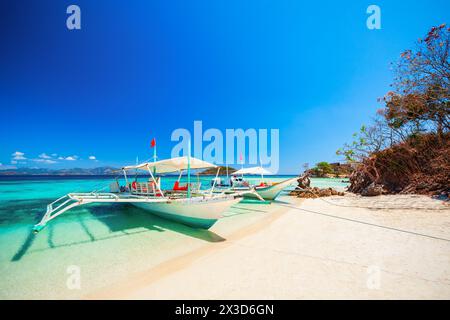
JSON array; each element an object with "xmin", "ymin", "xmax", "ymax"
[{"xmin": 0, "ymin": 0, "xmax": 450, "ymax": 173}]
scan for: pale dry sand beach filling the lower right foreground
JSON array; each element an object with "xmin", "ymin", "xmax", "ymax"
[{"xmin": 89, "ymin": 196, "xmax": 450, "ymax": 299}]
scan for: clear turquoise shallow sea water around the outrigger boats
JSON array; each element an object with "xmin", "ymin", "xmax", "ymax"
[{"xmin": 0, "ymin": 176, "xmax": 345, "ymax": 299}]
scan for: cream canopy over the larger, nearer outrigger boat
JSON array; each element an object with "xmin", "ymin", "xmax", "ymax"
[{"xmin": 122, "ymin": 156, "xmax": 217, "ymax": 173}]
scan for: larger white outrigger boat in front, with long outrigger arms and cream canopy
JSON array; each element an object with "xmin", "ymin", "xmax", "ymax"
[{"xmin": 33, "ymin": 156, "xmax": 262, "ymax": 233}]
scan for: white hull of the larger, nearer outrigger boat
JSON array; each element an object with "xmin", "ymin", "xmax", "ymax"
[{"xmin": 132, "ymin": 196, "xmax": 240, "ymax": 229}]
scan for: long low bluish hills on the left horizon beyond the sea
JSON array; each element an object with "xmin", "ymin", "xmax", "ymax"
[{"xmin": 0, "ymin": 167, "xmax": 117, "ymax": 176}]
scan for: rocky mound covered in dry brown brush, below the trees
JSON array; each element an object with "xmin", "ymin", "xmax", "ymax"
[{"xmin": 348, "ymin": 133, "xmax": 450, "ymax": 198}]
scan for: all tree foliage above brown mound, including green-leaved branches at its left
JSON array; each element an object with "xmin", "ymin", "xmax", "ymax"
[{"xmin": 336, "ymin": 24, "xmax": 450, "ymax": 162}]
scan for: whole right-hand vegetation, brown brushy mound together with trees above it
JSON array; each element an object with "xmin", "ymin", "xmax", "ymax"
[{"xmin": 337, "ymin": 24, "xmax": 450, "ymax": 197}]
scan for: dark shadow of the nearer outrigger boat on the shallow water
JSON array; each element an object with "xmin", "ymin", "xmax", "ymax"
[{"xmin": 11, "ymin": 204, "xmax": 226, "ymax": 261}]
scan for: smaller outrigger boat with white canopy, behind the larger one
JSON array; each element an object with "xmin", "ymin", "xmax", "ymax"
[{"xmin": 211, "ymin": 167, "xmax": 297, "ymax": 201}]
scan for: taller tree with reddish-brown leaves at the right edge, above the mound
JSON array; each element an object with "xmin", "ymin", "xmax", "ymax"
[{"xmin": 383, "ymin": 24, "xmax": 450, "ymax": 136}]
